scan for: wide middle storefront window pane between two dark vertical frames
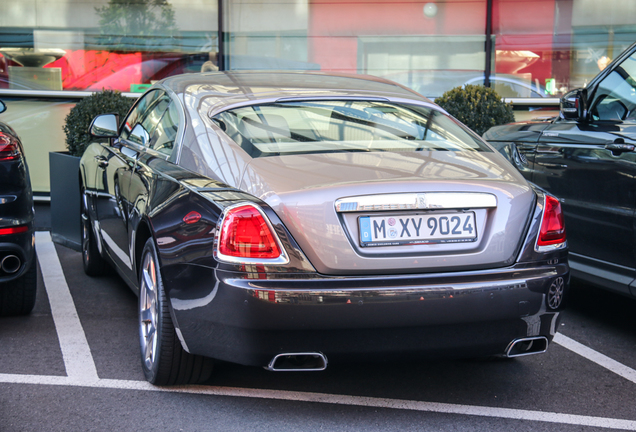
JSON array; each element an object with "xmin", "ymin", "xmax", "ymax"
[{"xmin": 226, "ymin": 0, "xmax": 486, "ymax": 97}]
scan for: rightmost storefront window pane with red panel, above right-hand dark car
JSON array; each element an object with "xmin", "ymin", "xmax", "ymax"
[{"xmin": 491, "ymin": 0, "xmax": 636, "ymax": 97}]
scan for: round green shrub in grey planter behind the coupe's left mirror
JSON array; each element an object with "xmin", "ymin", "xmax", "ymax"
[{"xmin": 64, "ymin": 90, "xmax": 135, "ymax": 156}]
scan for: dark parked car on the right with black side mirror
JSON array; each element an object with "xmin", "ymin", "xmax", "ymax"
[{"xmin": 484, "ymin": 44, "xmax": 636, "ymax": 296}]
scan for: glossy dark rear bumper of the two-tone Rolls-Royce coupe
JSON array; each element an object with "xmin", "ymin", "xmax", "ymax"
[{"xmin": 164, "ymin": 261, "xmax": 569, "ymax": 366}]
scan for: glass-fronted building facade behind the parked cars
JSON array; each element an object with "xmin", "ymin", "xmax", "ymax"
[{"xmin": 0, "ymin": 0, "xmax": 636, "ymax": 192}]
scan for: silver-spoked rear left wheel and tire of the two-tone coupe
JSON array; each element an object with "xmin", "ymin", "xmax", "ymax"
[{"xmin": 139, "ymin": 238, "xmax": 213, "ymax": 385}]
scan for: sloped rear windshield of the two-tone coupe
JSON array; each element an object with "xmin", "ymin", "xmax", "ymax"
[{"xmin": 212, "ymin": 101, "xmax": 490, "ymax": 157}]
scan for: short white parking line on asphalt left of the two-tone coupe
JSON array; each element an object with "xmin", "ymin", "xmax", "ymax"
[{"xmin": 35, "ymin": 231, "xmax": 99, "ymax": 381}]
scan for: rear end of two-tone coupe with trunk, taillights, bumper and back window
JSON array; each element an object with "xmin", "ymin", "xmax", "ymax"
[{"xmin": 167, "ymin": 90, "xmax": 569, "ymax": 370}]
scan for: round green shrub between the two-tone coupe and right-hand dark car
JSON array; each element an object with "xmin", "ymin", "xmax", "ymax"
[{"xmin": 435, "ymin": 84, "xmax": 515, "ymax": 136}]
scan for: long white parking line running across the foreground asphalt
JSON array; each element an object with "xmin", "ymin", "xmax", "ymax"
[{"xmin": 0, "ymin": 374, "xmax": 636, "ymax": 431}]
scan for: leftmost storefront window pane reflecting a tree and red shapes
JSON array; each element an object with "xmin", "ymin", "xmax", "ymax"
[{"xmin": 0, "ymin": 0, "xmax": 218, "ymax": 92}]
